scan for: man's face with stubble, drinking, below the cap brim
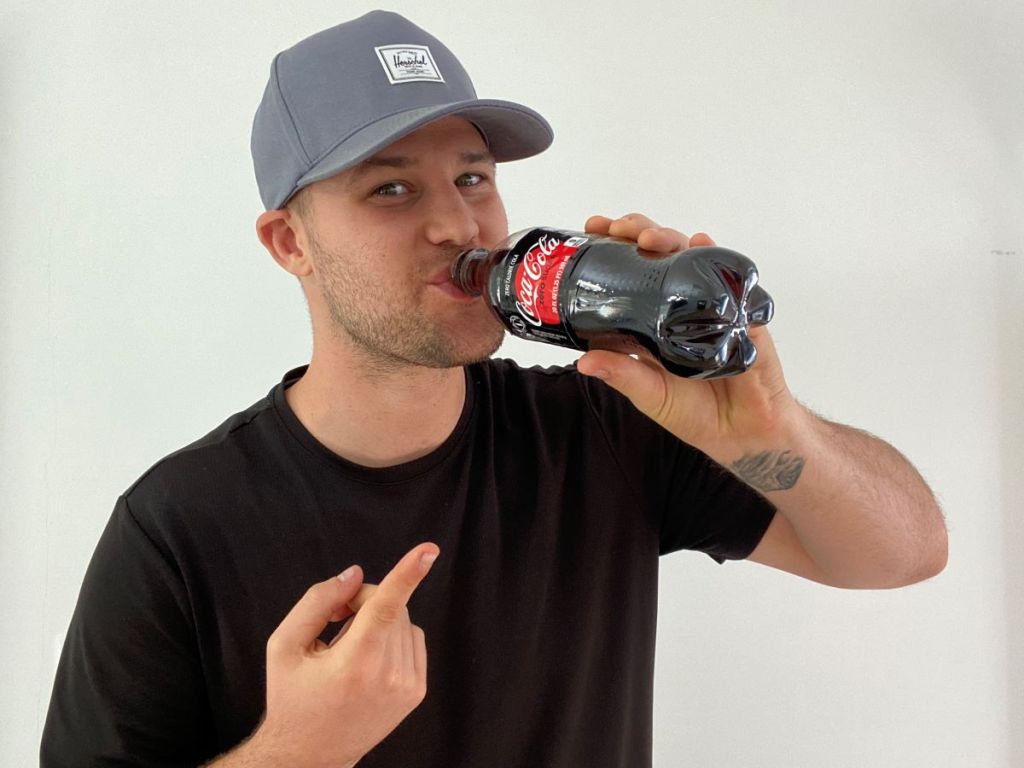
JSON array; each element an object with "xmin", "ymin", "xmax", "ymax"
[{"xmin": 292, "ymin": 118, "xmax": 508, "ymax": 370}]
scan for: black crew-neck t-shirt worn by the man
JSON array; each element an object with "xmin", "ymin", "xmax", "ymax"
[{"xmin": 41, "ymin": 360, "xmax": 774, "ymax": 768}]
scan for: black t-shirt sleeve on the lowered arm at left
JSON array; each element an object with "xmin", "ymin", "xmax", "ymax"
[{"xmin": 40, "ymin": 496, "xmax": 212, "ymax": 768}]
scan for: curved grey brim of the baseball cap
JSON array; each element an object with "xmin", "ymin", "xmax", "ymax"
[{"xmin": 275, "ymin": 99, "xmax": 554, "ymax": 208}]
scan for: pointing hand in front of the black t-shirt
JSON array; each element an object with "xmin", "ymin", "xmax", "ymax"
[{"xmin": 211, "ymin": 543, "xmax": 439, "ymax": 768}]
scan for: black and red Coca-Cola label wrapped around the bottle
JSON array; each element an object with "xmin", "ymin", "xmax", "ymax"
[{"xmin": 498, "ymin": 229, "xmax": 589, "ymax": 346}]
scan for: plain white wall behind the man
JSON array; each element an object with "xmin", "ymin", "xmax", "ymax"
[{"xmin": 0, "ymin": 0, "xmax": 1024, "ymax": 768}]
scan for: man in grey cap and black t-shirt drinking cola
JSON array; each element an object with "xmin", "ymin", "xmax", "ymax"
[{"xmin": 42, "ymin": 11, "xmax": 946, "ymax": 768}]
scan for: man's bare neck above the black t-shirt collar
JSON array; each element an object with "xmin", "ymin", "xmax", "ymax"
[{"xmin": 285, "ymin": 335, "xmax": 466, "ymax": 467}]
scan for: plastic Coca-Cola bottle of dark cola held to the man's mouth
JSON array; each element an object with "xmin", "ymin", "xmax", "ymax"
[{"xmin": 452, "ymin": 227, "xmax": 773, "ymax": 379}]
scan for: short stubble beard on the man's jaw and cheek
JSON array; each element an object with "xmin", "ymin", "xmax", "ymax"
[{"xmin": 310, "ymin": 232, "xmax": 505, "ymax": 373}]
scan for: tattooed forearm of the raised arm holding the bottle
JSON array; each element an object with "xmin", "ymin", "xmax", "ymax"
[{"xmin": 719, "ymin": 406, "xmax": 946, "ymax": 588}]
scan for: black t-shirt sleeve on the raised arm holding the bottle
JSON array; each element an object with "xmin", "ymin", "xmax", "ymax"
[{"xmin": 581, "ymin": 377, "xmax": 775, "ymax": 563}]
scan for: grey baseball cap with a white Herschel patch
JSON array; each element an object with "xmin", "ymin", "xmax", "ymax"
[{"xmin": 251, "ymin": 10, "xmax": 554, "ymax": 211}]
